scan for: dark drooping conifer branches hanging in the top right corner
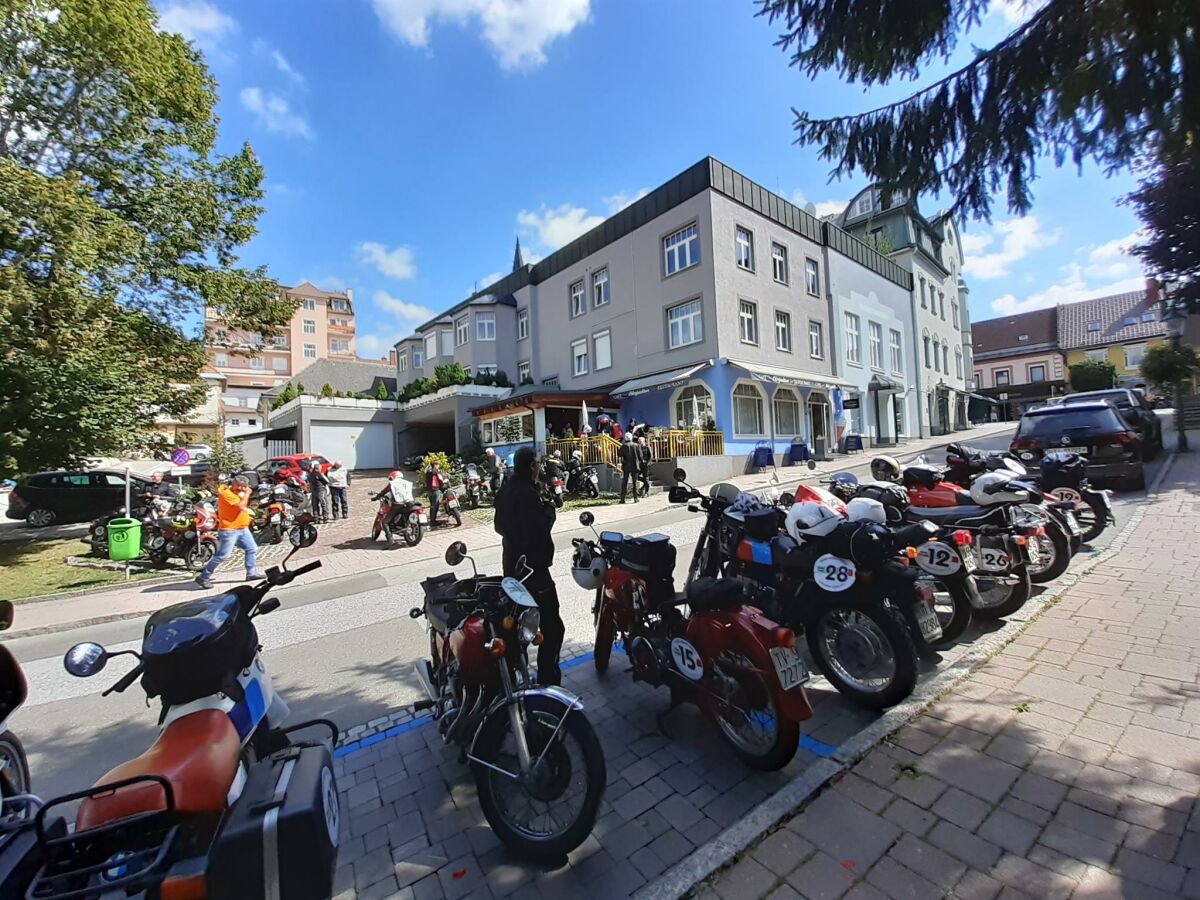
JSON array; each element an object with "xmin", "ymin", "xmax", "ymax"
[{"xmin": 758, "ymin": 0, "xmax": 1200, "ymax": 217}]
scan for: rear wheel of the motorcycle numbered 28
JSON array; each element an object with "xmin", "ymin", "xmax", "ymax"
[{"xmin": 804, "ymin": 600, "xmax": 917, "ymax": 709}]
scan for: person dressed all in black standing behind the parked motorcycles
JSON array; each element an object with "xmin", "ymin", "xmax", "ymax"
[{"xmin": 496, "ymin": 446, "xmax": 566, "ymax": 684}]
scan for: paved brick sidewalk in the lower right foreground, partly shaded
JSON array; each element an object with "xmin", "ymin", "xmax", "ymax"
[{"xmin": 698, "ymin": 454, "xmax": 1200, "ymax": 900}]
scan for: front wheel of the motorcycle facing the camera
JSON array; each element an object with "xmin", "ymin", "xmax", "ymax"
[{"xmin": 472, "ymin": 695, "xmax": 608, "ymax": 863}]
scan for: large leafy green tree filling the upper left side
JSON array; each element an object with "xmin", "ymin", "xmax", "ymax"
[{"xmin": 0, "ymin": 0, "xmax": 293, "ymax": 475}]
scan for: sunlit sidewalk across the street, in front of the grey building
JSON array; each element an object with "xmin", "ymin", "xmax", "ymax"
[{"xmin": 8, "ymin": 422, "xmax": 1014, "ymax": 636}]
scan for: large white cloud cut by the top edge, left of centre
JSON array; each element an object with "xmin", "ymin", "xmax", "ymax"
[{"xmin": 372, "ymin": 0, "xmax": 590, "ymax": 70}]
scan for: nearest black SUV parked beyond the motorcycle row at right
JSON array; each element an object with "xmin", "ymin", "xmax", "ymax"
[{"xmin": 1008, "ymin": 400, "xmax": 1146, "ymax": 491}]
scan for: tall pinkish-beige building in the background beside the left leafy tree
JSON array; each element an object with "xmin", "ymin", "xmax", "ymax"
[{"xmin": 204, "ymin": 282, "xmax": 355, "ymax": 434}]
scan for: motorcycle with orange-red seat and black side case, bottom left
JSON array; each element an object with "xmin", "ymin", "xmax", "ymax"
[{"xmin": 28, "ymin": 524, "xmax": 341, "ymax": 900}]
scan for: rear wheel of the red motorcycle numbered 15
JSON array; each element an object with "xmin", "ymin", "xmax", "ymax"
[{"xmin": 707, "ymin": 650, "xmax": 800, "ymax": 772}]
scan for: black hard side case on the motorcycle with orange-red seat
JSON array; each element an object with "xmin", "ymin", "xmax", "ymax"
[{"xmin": 205, "ymin": 744, "xmax": 341, "ymax": 900}]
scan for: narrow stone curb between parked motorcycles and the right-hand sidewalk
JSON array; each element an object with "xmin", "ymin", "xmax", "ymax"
[{"xmin": 634, "ymin": 451, "xmax": 1177, "ymax": 900}]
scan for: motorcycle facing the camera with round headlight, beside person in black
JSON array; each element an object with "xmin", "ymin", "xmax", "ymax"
[{"xmin": 409, "ymin": 541, "xmax": 607, "ymax": 863}]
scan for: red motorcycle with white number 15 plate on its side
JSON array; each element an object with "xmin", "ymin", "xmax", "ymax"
[{"xmin": 572, "ymin": 511, "xmax": 812, "ymax": 772}]
